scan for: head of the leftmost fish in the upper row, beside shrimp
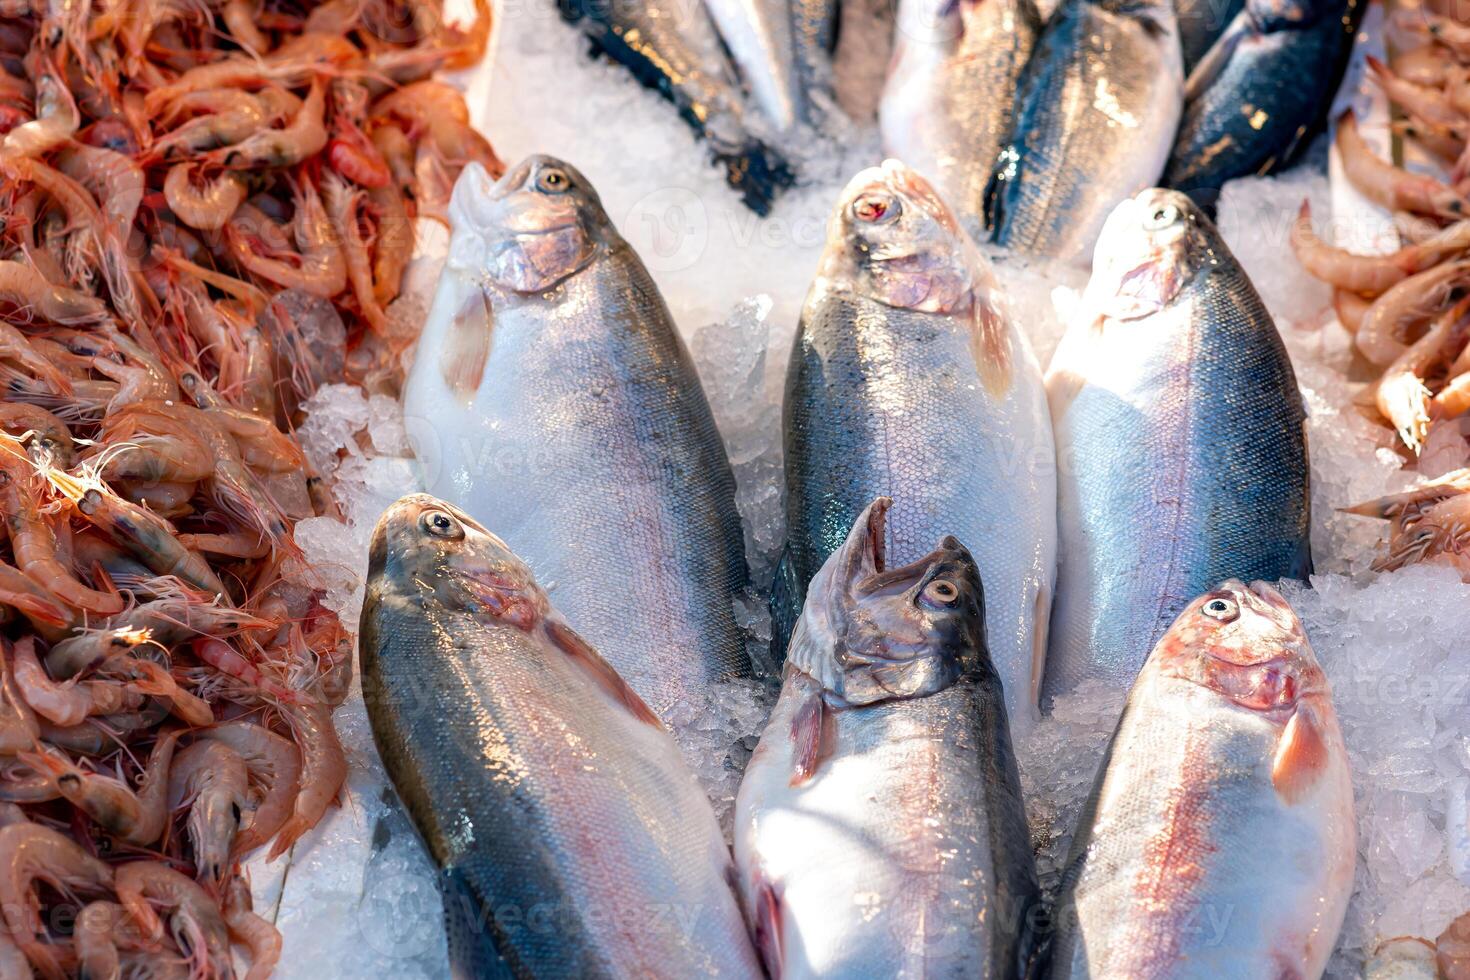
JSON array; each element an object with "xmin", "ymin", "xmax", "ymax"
[{"xmin": 450, "ymin": 154, "xmax": 605, "ymax": 292}]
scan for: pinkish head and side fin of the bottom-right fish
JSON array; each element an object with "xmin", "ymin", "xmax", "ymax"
[{"xmin": 1145, "ymin": 579, "xmax": 1347, "ymax": 804}]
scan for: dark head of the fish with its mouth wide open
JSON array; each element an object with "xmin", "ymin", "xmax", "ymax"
[{"xmin": 788, "ymin": 497, "xmax": 986, "ymax": 705}]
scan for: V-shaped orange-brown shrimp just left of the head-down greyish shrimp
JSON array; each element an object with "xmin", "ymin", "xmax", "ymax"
[{"xmin": 19, "ymin": 732, "xmax": 179, "ymax": 848}]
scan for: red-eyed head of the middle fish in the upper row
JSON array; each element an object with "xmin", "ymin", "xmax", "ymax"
[{"xmin": 820, "ymin": 160, "xmax": 989, "ymax": 313}]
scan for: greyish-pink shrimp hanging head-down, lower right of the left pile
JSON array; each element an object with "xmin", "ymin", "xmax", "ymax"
[{"xmin": 169, "ymin": 739, "xmax": 250, "ymax": 884}]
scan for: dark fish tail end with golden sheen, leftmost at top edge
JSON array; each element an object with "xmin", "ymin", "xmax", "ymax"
[{"xmin": 557, "ymin": 0, "xmax": 794, "ymax": 215}]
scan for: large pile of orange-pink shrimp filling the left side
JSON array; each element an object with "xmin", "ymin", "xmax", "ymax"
[{"xmin": 0, "ymin": 0, "xmax": 503, "ymax": 980}]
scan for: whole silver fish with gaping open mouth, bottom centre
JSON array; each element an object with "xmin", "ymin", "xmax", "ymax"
[{"xmin": 735, "ymin": 498, "xmax": 1038, "ymax": 980}]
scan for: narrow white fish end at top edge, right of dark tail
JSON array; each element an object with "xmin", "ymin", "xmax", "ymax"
[{"xmin": 704, "ymin": 0, "xmax": 807, "ymax": 132}]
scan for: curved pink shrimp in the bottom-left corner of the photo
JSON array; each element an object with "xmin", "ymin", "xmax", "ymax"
[{"xmin": 0, "ymin": 823, "xmax": 113, "ymax": 977}]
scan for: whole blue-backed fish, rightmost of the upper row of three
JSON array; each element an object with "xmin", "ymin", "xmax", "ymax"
[{"xmin": 1044, "ymin": 190, "xmax": 1311, "ymax": 699}]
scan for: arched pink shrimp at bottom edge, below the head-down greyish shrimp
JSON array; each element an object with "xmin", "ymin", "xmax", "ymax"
[{"xmin": 114, "ymin": 863, "xmax": 229, "ymax": 976}]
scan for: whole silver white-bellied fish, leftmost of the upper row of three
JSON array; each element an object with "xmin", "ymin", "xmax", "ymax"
[{"xmin": 404, "ymin": 156, "xmax": 750, "ymax": 718}]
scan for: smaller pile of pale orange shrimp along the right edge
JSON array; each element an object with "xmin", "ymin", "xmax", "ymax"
[{"xmin": 1291, "ymin": 10, "xmax": 1470, "ymax": 576}]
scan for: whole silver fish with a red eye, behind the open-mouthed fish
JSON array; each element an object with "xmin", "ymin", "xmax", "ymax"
[{"xmin": 773, "ymin": 160, "xmax": 1057, "ymax": 724}]
